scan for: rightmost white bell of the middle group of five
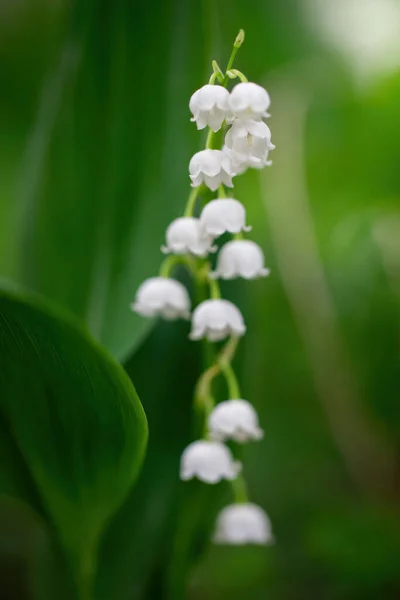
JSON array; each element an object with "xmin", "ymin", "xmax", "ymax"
[{"xmin": 210, "ymin": 240, "xmax": 270, "ymax": 279}]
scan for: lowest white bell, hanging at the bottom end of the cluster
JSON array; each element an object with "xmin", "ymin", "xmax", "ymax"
[{"xmin": 213, "ymin": 502, "xmax": 274, "ymax": 546}]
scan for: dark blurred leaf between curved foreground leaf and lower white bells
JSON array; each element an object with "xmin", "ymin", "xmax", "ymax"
[{"xmin": 96, "ymin": 322, "xmax": 199, "ymax": 600}]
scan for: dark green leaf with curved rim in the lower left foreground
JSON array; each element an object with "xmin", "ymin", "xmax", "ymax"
[{"xmin": 0, "ymin": 291, "xmax": 147, "ymax": 598}]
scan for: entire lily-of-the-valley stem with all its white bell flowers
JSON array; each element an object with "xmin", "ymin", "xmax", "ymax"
[{"xmin": 132, "ymin": 32, "xmax": 274, "ymax": 544}]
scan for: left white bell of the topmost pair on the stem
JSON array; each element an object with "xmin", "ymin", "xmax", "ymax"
[{"xmin": 189, "ymin": 84, "xmax": 229, "ymax": 131}]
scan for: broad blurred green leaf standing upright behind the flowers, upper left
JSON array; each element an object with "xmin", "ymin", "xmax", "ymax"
[{"xmin": 17, "ymin": 0, "xmax": 203, "ymax": 359}]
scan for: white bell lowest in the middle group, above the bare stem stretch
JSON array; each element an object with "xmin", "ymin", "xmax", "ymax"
[{"xmin": 189, "ymin": 299, "xmax": 246, "ymax": 342}]
